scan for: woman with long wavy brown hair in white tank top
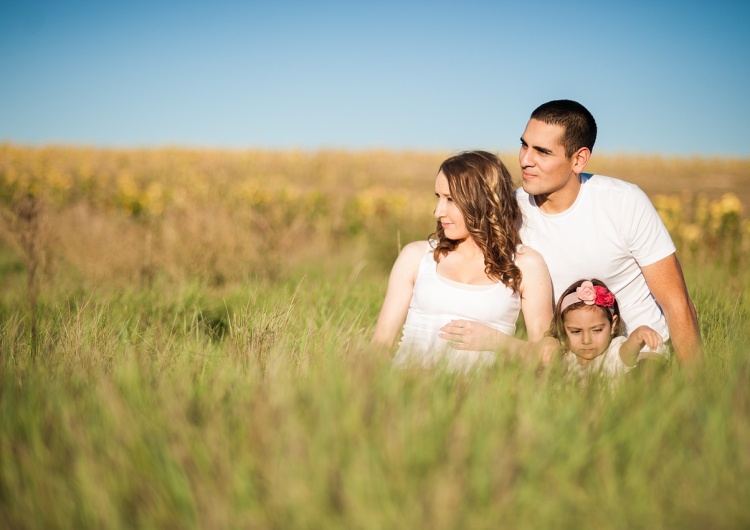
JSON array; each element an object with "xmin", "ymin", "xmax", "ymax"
[{"xmin": 372, "ymin": 151, "xmax": 552, "ymax": 370}]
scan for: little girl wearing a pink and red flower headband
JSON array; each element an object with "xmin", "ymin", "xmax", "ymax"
[{"xmin": 549, "ymin": 279, "xmax": 663, "ymax": 377}]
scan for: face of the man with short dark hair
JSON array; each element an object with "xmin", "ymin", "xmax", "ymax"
[{"xmin": 518, "ymin": 119, "xmax": 578, "ymax": 195}]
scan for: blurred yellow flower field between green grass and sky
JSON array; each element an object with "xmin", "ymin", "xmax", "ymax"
[{"xmin": 0, "ymin": 144, "xmax": 750, "ymax": 283}]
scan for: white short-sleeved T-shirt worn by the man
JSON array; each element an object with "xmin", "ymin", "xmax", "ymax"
[{"xmin": 516, "ymin": 173, "xmax": 675, "ymax": 342}]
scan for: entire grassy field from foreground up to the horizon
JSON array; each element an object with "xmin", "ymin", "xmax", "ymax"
[{"xmin": 0, "ymin": 145, "xmax": 750, "ymax": 529}]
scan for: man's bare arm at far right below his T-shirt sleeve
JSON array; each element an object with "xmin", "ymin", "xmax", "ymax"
[{"xmin": 641, "ymin": 254, "xmax": 703, "ymax": 365}]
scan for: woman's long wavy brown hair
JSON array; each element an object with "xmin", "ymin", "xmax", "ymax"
[{"xmin": 430, "ymin": 151, "xmax": 521, "ymax": 292}]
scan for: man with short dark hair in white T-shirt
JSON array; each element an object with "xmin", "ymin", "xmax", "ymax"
[{"xmin": 441, "ymin": 100, "xmax": 703, "ymax": 364}]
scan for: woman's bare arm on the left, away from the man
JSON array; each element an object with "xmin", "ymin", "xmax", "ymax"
[{"xmin": 370, "ymin": 241, "xmax": 427, "ymax": 352}]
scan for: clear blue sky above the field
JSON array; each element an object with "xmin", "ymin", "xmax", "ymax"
[{"xmin": 0, "ymin": 0, "xmax": 750, "ymax": 157}]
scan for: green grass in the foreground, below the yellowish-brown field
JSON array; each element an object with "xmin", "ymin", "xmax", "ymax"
[{"xmin": 0, "ymin": 253, "xmax": 750, "ymax": 529}]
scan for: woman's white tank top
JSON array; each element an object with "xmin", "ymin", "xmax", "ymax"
[{"xmin": 394, "ymin": 243, "xmax": 521, "ymax": 369}]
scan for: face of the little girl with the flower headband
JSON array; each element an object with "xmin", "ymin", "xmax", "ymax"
[{"xmin": 565, "ymin": 305, "xmax": 617, "ymax": 366}]
